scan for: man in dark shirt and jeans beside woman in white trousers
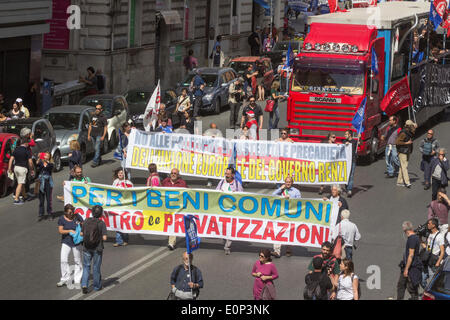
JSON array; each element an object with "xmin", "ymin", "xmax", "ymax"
[{"xmin": 81, "ymin": 205, "xmax": 107, "ymax": 294}]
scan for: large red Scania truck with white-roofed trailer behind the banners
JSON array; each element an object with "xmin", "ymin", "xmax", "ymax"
[{"xmin": 287, "ymin": 2, "xmax": 444, "ymax": 161}]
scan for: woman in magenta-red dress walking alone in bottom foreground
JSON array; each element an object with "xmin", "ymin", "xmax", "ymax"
[{"xmin": 252, "ymin": 249, "xmax": 278, "ymax": 300}]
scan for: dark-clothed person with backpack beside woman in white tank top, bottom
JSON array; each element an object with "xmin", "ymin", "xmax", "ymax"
[{"xmin": 303, "ymin": 256, "xmax": 333, "ymax": 300}]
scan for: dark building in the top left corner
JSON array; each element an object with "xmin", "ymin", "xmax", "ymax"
[{"xmin": 0, "ymin": 0, "xmax": 52, "ymax": 109}]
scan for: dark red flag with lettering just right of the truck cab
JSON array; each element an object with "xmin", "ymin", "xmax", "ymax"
[{"xmin": 380, "ymin": 77, "xmax": 413, "ymax": 116}]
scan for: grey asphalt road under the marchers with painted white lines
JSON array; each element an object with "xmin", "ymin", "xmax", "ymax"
[{"xmin": 0, "ymin": 103, "xmax": 450, "ymax": 300}]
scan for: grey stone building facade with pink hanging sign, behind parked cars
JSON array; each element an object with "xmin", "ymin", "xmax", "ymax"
[{"xmin": 42, "ymin": 0, "xmax": 284, "ymax": 93}]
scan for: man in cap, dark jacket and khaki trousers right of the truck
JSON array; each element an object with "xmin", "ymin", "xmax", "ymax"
[{"xmin": 395, "ymin": 120, "xmax": 417, "ymax": 188}]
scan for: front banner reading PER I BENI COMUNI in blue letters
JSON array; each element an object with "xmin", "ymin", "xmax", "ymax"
[{"xmin": 64, "ymin": 181, "xmax": 339, "ymax": 248}]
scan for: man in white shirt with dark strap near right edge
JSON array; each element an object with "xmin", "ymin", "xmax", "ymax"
[{"xmin": 421, "ymin": 218, "xmax": 445, "ymax": 289}]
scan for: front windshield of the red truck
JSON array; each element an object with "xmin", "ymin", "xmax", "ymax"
[{"xmin": 291, "ymin": 66, "xmax": 364, "ymax": 95}]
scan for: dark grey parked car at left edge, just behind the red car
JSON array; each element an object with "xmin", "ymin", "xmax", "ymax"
[{"xmin": 0, "ymin": 117, "xmax": 62, "ymax": 172}]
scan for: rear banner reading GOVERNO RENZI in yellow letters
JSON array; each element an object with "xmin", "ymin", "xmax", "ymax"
[{"xmin": 126, "ymin": 129, "xmax": 352, "ymax": 184}]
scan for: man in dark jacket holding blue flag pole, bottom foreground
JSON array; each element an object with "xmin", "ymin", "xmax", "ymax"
[{"xmin": 169, "ymin": 252, "xmax": 203, "ymax": 300}]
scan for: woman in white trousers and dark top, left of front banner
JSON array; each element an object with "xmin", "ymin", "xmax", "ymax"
[{"xmin": 56, "ymin": 204, "xmax": 83, "ymax": 289}]
